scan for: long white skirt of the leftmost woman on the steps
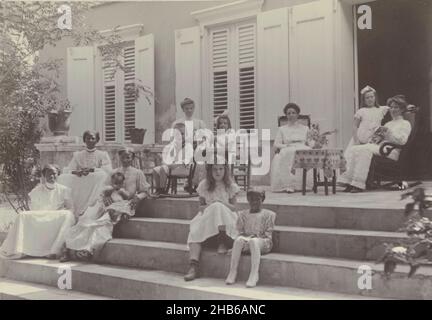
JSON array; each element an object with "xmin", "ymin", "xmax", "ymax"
[{"xmin": 0, "ymin": 210, "xmax": 75, "ymax": 259}]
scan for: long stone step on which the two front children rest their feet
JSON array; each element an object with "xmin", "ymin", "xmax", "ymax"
[{"xmin": 0, "ymin": 259, "xmax": 378, "ymax": 300}]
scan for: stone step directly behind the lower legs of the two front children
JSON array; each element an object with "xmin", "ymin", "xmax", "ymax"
[{"xmin": 98, "ymin": 239, "xmax": 432, "ymax": 299}]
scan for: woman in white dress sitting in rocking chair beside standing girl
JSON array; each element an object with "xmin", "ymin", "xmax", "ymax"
[{"xmin": 339, "ymin": 95, "xmax": 411, "ymax": 193}]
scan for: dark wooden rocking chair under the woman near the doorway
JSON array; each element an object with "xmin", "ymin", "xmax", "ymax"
[{"xmin": 366, "ymin": 108, "xmax": 420, "ymax": 189}]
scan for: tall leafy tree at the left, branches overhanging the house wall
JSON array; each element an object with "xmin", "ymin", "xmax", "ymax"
[{"xmin": 0, "ymin": 1, "xmax": 152, "ymax": 212}]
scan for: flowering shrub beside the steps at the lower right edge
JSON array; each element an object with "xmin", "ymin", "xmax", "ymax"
[{"xmin": 378, "ymin": 188, "xmax": 432, "ymax": 277}]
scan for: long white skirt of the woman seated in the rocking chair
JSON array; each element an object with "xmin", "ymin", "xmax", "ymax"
[{"xmin": 339, "ymin": 143, "xmax": 380, "ymax": 189}]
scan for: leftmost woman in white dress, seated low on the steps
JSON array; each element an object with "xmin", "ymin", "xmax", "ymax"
[{"xmin": 0, "ymin": 165, "xmax": 75, "ymax": 259}]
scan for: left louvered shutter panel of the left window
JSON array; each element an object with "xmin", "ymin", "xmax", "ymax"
[{"xmin": 102, "ymin": 56, "xmax": 119, "ymax": 142}]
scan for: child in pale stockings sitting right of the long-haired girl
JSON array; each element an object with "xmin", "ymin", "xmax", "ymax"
[{"xmin": 225, "ymin": 189, "xmax": 276, "ymax": 288}]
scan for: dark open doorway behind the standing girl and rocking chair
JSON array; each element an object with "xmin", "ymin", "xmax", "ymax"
[{"xmin": 356, "ymin": 0, "xmax": 432, "ymax": 176}]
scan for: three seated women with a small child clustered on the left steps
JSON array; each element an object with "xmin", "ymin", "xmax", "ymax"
[{"xmin": 0, "ymin": 131, "xmax": 150, "ymax": 262}]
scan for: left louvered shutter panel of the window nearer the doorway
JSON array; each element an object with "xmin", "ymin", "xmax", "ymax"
[{"xmin": 210, "ymin": 28, "xmax": 229, "ymax": 127}]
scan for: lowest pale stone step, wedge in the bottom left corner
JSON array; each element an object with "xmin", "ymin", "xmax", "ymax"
[{"xmin": 0, "ymin": 278, "xmax": 112, "ymax": 300}]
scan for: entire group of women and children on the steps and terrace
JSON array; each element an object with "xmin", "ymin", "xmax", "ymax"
[{"xmin": 0, "ymin": 87, "xmax": 411, "ymax": 287}]
